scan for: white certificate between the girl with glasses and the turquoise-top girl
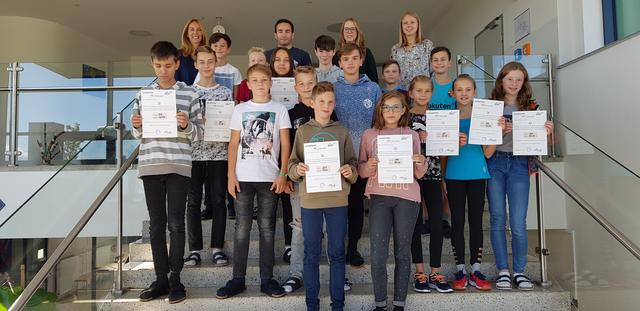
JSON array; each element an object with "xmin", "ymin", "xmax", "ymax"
[{"xmin": 426, "ymin": 110, "xmax": 460, "ymax": 156}]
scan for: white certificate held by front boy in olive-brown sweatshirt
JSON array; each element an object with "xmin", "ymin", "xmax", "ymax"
[{"xmin": 304, "ymin": 141, "xmax": 342, "ymax": 193}]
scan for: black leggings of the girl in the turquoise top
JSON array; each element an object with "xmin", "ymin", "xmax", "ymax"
[{"xmin": 447, "ymin": 179, "xmax": 487, "ymax": 265}]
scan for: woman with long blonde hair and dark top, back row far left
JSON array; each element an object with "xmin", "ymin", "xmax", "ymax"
[{"xmin": 176, "ymin": 18, "xmax": 207, "ymax": 85}]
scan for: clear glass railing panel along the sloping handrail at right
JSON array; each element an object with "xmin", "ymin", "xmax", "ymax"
[{"xmin": 528, "ymin": 121, "xmax": 640, "ymax": 310}]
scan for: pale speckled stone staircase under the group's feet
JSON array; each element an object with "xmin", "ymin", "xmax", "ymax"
[{"xmin": 103, "ymin": 213, "xmax": 570, "ymax": 311}]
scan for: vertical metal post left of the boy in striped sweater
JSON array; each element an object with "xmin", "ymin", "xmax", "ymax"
[{"xmin": 112, "ymin": 112, "xmax": 124, "ymax": 296}]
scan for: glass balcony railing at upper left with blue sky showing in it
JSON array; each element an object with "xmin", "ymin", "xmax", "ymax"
[{"xmin": 0, "ymin": 61, "xmax": 154, "ymax": 170}]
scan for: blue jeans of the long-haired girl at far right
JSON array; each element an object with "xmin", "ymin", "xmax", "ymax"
[{"xmin": 487, "ymin": 151, "xmax": 530, "ymax": 273}]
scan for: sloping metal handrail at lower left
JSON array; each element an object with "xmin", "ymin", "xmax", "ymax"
[{"xmin": 9, "ymin": 145, "xmax": 140, "ymax": 311}]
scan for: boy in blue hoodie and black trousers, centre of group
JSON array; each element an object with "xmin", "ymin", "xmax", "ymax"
[{"xmin": 334, "ymin": 43, "xmax": 382, "ymax": 270}]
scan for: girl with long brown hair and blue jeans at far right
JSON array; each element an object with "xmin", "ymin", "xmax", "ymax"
[{"xmin": 487, "ymin": 62, "xmax": 553, "ymax": 290}]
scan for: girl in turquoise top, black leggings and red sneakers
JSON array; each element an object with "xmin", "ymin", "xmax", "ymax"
[{"xmin": 445, "ymin": 74, "xmax": 505, "ymax": 290}]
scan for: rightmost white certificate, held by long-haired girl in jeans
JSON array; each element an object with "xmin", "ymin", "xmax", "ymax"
[{"xmin": 513, "ymin": 111, "xmax": 547, "ymax": 155}]
